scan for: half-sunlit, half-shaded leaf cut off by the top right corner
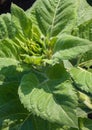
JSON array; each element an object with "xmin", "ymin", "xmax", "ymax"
[{"xmin": 72, "ymin": 0, "xmax": 92, "ymax": 41}]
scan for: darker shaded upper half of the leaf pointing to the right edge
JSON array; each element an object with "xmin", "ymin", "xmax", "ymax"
[{"xmin": 54, "ymin": 34, "xmax": 92, "ymax": 52}]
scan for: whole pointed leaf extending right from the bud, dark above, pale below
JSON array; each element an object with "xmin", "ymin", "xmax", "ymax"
[{"xmin": 52, "ymin": 34, "xmax": 92, "ymax": 63}]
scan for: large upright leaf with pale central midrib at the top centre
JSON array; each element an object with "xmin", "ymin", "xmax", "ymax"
[{"xmin": 27, "ymin": 0, "xmax": 78, "ymax": 37}]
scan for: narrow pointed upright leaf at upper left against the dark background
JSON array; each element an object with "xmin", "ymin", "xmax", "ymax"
[{"xmin": 11, "ymin": 4, "xmax": 32, "ymax": 39}]
